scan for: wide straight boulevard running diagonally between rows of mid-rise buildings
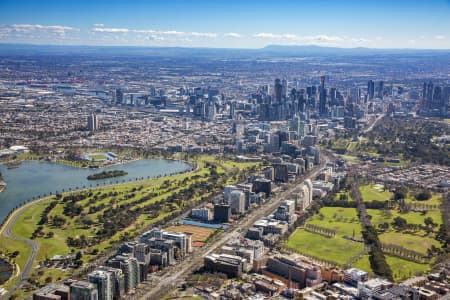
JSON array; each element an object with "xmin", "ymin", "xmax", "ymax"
[{"xmin": 135, "ymin": 158, "xmax": 329, "ymax": 299}]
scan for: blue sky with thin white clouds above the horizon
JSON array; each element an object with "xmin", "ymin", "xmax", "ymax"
[{"xmin": 0, "ymin": 0, "xmax": 450, "ymax": 49}]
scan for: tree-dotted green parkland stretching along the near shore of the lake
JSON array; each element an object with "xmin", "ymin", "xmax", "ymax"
[{"xmin": 0, "ymin": 155, "xmax": 258, "ymax": 298}]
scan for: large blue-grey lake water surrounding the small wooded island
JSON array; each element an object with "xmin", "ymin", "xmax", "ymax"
[{"xmin": 0, "ymin": 159, "xmax": 191, "ymax": 222}]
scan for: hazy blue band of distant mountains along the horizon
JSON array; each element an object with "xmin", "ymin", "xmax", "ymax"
[{"xmin": 0, "ymin": 43, "xmax": 450, "ymax": 59}]
